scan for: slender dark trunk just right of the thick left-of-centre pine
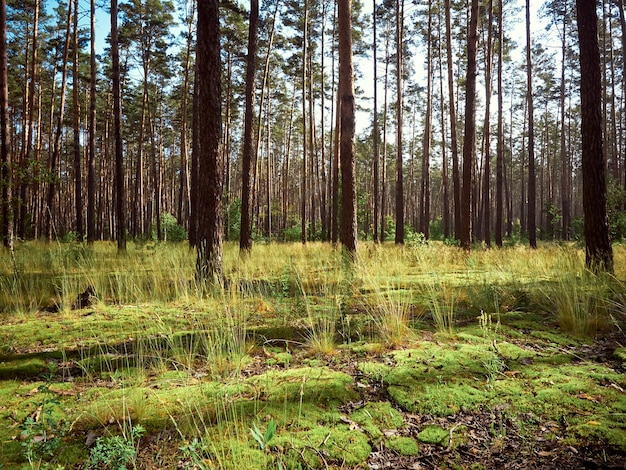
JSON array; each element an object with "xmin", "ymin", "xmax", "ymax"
[{"xmin": 239, "ymin": 0, "xmax": 258, "ymax": 256}]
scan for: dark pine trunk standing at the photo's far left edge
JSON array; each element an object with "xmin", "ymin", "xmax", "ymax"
[{"xmin": 0, "ymin": 0, "xmax": 13, "ymax": 250}]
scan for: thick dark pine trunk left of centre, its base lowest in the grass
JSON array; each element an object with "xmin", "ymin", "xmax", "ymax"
[{"xmin": 193, "ymin": 0, "xmax": 224, "ymax": 284}]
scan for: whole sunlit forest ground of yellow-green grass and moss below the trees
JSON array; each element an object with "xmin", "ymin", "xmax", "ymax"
[{"xmin": 0, "ymin": 242, "xmax": 626, "ymax": 469}]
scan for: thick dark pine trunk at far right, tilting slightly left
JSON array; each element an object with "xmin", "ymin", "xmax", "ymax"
[{"xmin": 576, "ymin": 0, "xmax": 613, "ymax": 273}]
